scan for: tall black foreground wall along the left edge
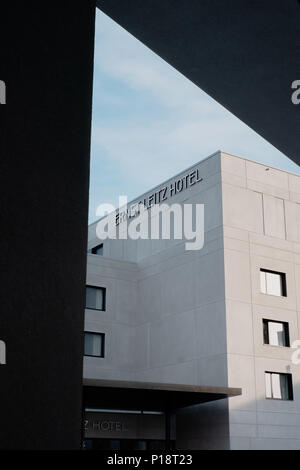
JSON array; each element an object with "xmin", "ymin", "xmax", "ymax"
[{"xmin": 0, "ymin": 0, "xmax": 95, "ymax": 449}]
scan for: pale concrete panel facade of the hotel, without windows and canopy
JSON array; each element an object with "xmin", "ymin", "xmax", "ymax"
[{"xmin": 84, "ymin": 152, "xmax": 300, "ymax": 449}]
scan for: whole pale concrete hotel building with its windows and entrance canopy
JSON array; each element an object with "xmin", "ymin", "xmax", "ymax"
[{"xmin": 84, "ymin": 151, "xmax": 300, "ymax": 450}]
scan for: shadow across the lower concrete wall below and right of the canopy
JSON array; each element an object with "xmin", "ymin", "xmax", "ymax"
[{"xmin": 176, "ymin": 380, "xmax": 300, "ymax": 450}]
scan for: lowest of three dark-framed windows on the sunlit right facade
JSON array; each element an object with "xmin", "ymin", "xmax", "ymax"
[{"xmin": 265, "ymin": 372, "xmax": 293, "ymax": 400}]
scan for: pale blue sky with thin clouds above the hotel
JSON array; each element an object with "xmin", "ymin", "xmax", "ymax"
[{"xmin": 89, "ymin": 10, "xmax": 300, "ymax": 222}]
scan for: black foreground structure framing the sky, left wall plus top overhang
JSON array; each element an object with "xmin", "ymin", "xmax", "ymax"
[{"xmin": 0, "ymin": 0, "xmax": 300, "ymax": 449}]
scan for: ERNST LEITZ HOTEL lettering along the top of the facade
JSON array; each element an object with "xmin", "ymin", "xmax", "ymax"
[{"xmin": 116, "ymin": 169, "xmax": 203, "ymax": 225}]
